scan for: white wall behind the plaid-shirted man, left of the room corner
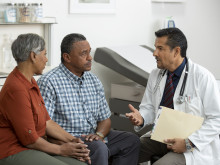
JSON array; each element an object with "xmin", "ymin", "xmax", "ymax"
[{"xmin": 42, "ymin": 0, "xmax": 156, "ymax": 99}]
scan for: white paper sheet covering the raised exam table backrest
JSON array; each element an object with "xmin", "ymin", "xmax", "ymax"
[{"xmin": 109, "ymin": 45, "xmax": 157, "ymax": 73}]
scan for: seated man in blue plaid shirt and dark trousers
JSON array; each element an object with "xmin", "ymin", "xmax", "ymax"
[{"xmin": 38, "ymin": 34, "xmax": 140, "ymax": 165}]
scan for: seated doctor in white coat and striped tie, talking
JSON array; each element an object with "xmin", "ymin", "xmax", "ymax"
[{"xmin": 126, "ymin": 28, "xmax": 220, "ymax": 165}]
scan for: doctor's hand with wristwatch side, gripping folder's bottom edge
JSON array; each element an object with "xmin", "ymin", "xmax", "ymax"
[{"xmin": 164, "ymin": 138, "xmax": 186, "ymax": 154}]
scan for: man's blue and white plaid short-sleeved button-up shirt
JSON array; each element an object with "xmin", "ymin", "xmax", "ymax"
[{"xmin": 38, "ymin": 64, "xmax": 111, "ymax": 136}]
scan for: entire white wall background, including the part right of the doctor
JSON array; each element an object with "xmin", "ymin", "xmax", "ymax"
[{"xmin": 0, "ymin": 0, "xmax": 220, "ymax": 98}]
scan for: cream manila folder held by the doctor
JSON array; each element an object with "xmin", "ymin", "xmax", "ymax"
[{"xmin": 151, "ymin": 107, "xmax": 204, "ymax": 143}]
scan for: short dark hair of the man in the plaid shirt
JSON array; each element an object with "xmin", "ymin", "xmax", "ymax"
[{"xmin": 60, "ymin": 33, "xmax": 86, "ymax": 63}]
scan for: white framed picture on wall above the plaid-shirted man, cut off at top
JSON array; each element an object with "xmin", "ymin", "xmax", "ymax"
[{"xmin": 69, "ymin": 0, "xmax": 116, "ymax": 13}]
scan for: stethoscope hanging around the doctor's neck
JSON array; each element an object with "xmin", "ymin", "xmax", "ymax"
[{"xmin": 154, "ymin": 57, "xmax": 189, "ymax": 104}]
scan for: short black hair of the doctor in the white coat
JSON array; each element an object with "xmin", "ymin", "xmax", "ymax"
[{"xmin": 155, "ymin": 28, "xmax": 187, "ymax": 57}]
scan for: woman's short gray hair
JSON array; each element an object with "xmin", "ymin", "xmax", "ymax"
[{"xmin": 11, "ymin": 33, "xmax": 45, "ymax": 63}]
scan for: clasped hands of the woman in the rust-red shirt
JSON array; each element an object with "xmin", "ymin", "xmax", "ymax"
[{"xmin": 60, "ymin": 142, "xmax": 91, "ymax": 164}]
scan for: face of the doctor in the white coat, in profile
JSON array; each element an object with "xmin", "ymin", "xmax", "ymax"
[{"xmin": 153, "ymin": 36, "xmax": 174, "ymax": 70}]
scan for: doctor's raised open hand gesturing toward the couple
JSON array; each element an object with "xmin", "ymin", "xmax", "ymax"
[{"xmin": 125, "ymin": 104, "xmax": 144, "ymax": 126}]
